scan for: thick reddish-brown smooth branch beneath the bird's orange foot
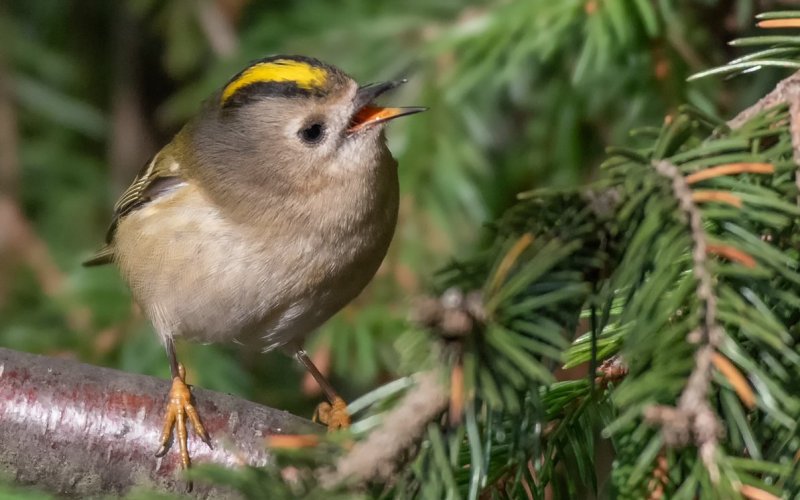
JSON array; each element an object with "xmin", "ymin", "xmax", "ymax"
[{"xmin": 0, "ymin": 348, "xmax": 319, "ymax": 498}]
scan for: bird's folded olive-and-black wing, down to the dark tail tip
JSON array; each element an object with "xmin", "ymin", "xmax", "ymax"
[{"xmin": 83, "ymin": 153, "xmax": 184, "ymax": 266}]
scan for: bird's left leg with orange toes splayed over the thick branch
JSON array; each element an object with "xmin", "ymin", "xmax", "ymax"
[{"xmin": 156, "ymin": 339, "xmax": 211, "ymax": 489}]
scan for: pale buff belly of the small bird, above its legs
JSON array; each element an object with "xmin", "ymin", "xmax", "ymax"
[{"xmin": 115, "ymin": 182, "xmax": 394, "ymax": 350}]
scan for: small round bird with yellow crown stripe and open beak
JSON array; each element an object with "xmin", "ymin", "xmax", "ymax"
[{"xmin": 85, "ymin": 56, "xmax": 425, "ymax": 476}]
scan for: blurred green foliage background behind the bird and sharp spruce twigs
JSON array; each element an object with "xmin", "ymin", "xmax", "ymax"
[{"xmin": 0, "ymin": 0, "xmax": 780, "ymax": 416}]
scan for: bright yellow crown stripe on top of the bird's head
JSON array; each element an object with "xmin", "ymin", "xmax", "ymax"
[{"xmin": 222, "ymin": 59, "xmax": 328, "ymax": 104}]
